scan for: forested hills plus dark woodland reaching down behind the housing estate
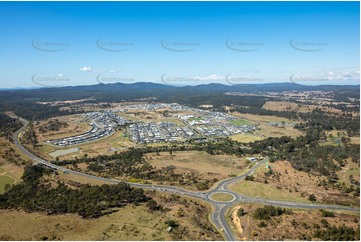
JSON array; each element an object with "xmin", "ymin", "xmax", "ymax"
[{"xmin": 0, "ymin": 82, "xmax": 360, "ymax": 120}]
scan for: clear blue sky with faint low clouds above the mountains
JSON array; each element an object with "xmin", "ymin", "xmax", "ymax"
[{"xmin": 0, "ymin": 2, "xmax": 360, "ymax": 88}]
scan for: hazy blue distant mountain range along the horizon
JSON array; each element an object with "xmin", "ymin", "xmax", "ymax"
[{"xmin": 0, "ymin": 82, "xmax": 360, "ymax": 101}]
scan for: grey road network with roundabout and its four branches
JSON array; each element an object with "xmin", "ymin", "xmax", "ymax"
[{"xmin": 13, "ymin": 117, "xmax": 360, "ymax": 241}]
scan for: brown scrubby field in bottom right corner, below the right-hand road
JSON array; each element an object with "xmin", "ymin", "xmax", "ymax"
[{"xmin": 227, "ymin": 203, "xmax": 360, "ymax": 241}]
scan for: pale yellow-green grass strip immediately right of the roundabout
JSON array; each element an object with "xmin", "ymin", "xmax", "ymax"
[{"xmin": 230, "ymin": 181, "xmax": 310, "ymax": 202}]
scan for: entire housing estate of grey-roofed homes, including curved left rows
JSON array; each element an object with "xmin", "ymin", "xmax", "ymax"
[{"xmin": 47, "ymin": 103, "xmax": 258, "ymax": 146}]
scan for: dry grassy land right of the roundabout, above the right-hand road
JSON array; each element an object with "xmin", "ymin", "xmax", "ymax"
[{"xmin": 231, "ymin": 161, "xmax": 359, "ymax": 206}]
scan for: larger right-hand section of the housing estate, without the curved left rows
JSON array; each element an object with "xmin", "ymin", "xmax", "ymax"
[{"xmin": 119, "ymin": 103, "xmax": 258, "ymax": 143}]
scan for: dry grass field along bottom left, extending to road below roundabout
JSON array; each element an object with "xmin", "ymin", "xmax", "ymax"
[{"xmin": 0, "ymin": 194, "xmax": 222, "ymax": 241}]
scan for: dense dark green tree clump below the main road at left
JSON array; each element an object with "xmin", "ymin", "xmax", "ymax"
[{"xmin": 0, "ymin": 166, "xmax": 151, "ymax": 218}]
